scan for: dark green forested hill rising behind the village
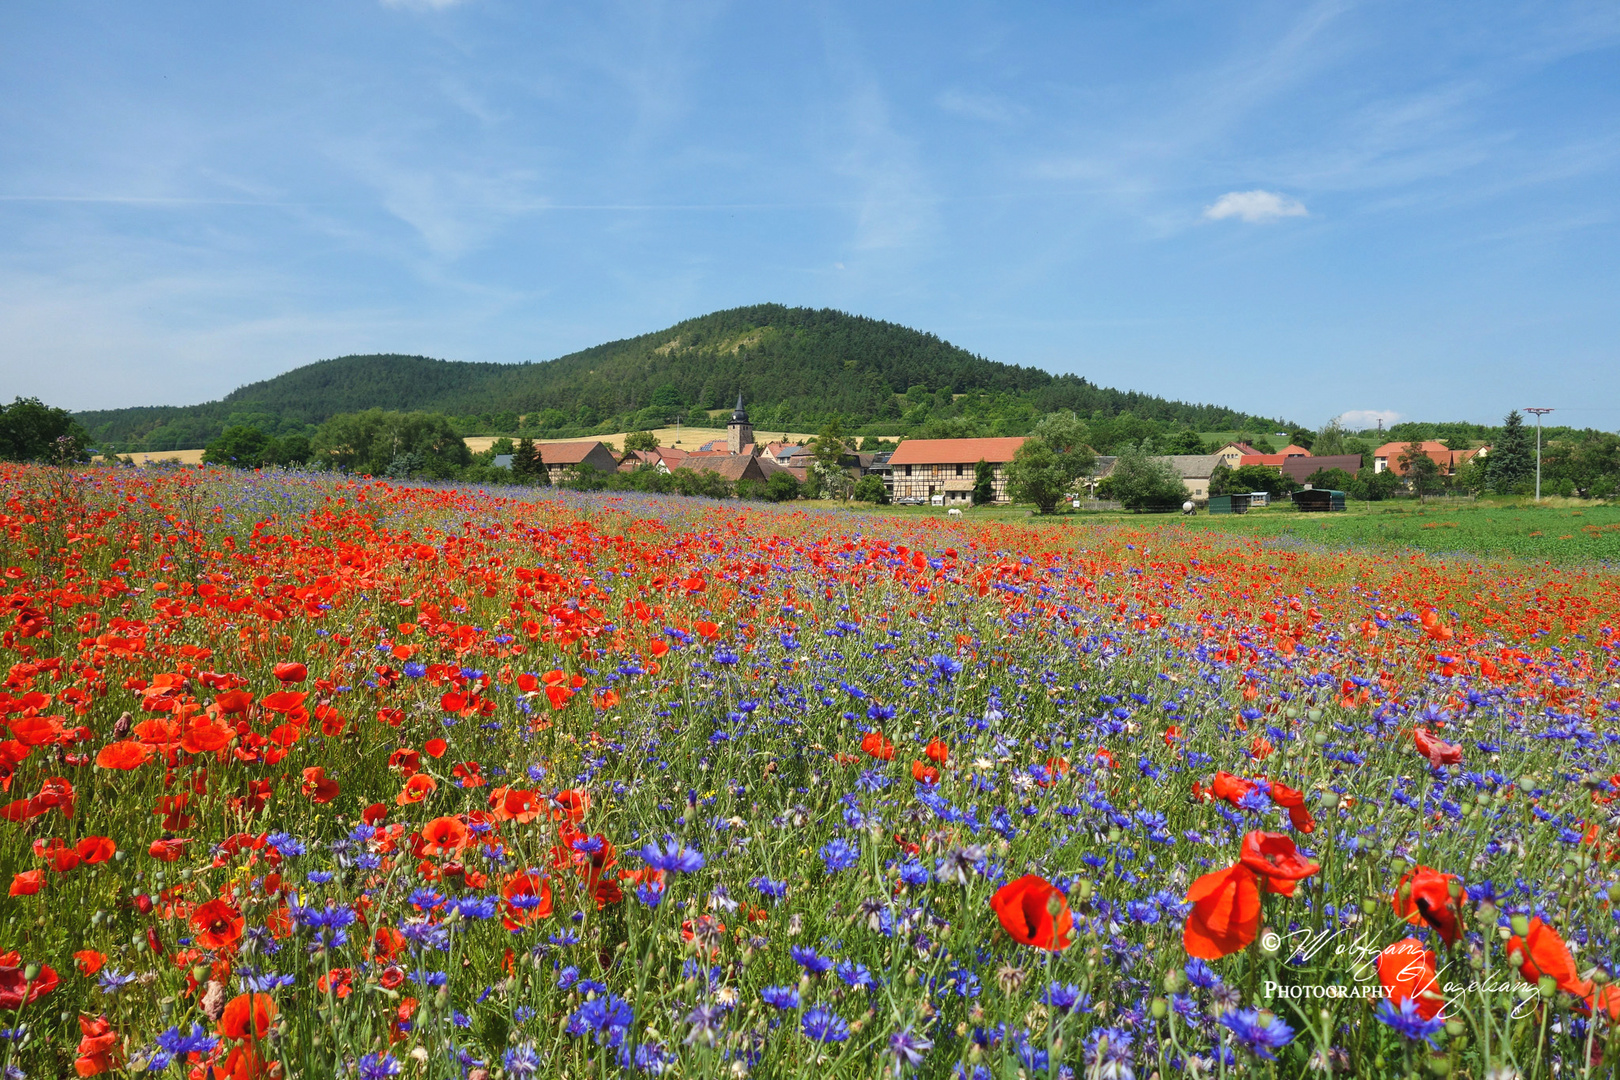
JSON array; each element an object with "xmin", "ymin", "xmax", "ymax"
[{"xmin": 79, "ymin": 304, "xmax": 1280, "ymax": 450}]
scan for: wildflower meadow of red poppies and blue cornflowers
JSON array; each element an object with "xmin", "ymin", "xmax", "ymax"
[{"xmin": 0, "ymin": 466, "xmax": 1620, "ymax": 1080}]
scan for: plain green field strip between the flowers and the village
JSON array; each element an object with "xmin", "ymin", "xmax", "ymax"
[{"xmin": 861, "ymin": 499, "xmax": 1620, "ymax": 563}]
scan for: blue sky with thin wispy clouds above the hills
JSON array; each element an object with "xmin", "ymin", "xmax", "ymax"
[{"xmin": 0, "ymin": 0, "xmax": 1620, "ymax": 429}]
